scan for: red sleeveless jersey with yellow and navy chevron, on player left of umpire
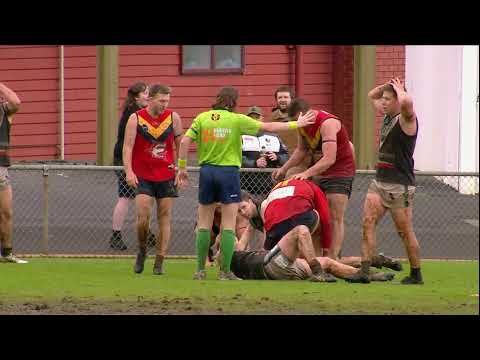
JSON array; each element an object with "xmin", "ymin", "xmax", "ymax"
[{"xmin": 132, "ymin": 108, "xmax": 175, "ymax": 181}]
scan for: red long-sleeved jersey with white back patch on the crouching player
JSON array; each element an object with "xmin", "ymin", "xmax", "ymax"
[{"xmin": 264, "ymin": 179, "xmax": 332, "ymax": 249}]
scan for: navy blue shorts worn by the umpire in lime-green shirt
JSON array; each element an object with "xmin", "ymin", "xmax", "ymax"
[{"xmin": 198, "ymin": 165, "xmax": 240, "ymax": 205}]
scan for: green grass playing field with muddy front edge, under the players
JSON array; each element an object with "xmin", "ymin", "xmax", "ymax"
[{"xmin": 0, "ymin": 258, "xmax": 479, "ymax": 315}]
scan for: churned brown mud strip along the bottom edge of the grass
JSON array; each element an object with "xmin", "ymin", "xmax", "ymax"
[{"xmin": 0, "ymin": 292, "xmax": 478, "ymax": 315}]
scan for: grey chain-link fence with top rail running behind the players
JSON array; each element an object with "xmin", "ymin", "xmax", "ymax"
[{"xmin": 9, "ymin": 165, "xmax": 479, "ymax": 259}]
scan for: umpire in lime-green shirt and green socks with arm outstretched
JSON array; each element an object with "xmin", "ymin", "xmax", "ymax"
[{"xmin": 177, "ymin": 87, "xmax": 313, "ymax": 280}]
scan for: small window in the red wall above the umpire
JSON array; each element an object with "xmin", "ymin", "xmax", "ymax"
[{"xmin": 182, "ymin": 45, "xmax": 244, "ymax": 74}]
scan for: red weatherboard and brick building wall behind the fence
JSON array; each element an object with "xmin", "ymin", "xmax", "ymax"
[{"xmin": 0, "ymin": 45, "xmax": 405, "ymax": 161}]
